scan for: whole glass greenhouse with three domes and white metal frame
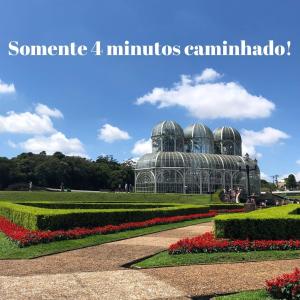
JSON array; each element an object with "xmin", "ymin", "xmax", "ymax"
[{"xmin": 135, "ymin": 121, "xmax": 260, "ymax": 194}]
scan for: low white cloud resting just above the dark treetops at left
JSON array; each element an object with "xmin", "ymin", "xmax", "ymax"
[{"xmin": 19, "ymin": 132, "xmax": 87, "ymax": 157}]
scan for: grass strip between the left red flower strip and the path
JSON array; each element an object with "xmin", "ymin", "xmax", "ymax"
[{"xmin": 0, "ymin": 218, "xmax": 212, "ymax": 259}]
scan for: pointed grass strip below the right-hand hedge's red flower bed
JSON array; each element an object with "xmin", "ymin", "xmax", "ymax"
[{"xmin": 132, "ymin": 250, "xmax": 300, "ymax": 268}]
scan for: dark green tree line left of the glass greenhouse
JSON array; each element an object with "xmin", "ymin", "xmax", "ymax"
[{"xmin": 0, "ymin": 151, "xmax": 134, "ymax": 190}]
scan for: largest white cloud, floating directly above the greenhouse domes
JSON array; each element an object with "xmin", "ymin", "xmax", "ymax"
[{"xmin": 136, "ymin": 69, "xmax": 275, "ymax": 119}]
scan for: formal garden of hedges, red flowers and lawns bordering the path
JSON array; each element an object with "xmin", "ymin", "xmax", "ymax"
[{"xmin": 0, "ymin": 192, "xmax": 300, "ymax": 299}]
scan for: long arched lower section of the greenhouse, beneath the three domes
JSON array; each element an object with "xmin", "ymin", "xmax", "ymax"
[{"xmin": 135, "ymin": 152, "xmax": 260, "ymax": 194}]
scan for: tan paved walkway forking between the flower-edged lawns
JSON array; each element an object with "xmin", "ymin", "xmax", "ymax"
[{"xmin": 0, "ymin": 223, "xmax": 300, "ymax": 300}]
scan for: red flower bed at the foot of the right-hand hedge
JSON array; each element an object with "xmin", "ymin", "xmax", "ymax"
[{"xmin": 169, "ymin": 232, "xmax": 300, "ymax": 254}]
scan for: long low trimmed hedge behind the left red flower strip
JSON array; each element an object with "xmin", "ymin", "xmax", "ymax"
[{"xmin": 0, "ymin": 202, "xmax": 209, "ymax": 230}]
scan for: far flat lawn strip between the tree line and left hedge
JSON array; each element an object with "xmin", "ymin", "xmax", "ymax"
[{"xmin": 0, "ymin": 191, "xmax": 212, "ymax": 205}]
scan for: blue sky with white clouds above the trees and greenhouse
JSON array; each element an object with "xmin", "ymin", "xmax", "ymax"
[{"xmin": 0, "ymin": 0, "xmax": 300, "ymax": 182}]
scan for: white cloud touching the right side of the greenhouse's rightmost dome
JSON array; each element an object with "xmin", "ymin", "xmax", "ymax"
[{"xmin": 242, "ymin": 127, "xmax": 289, "ymax": 158}]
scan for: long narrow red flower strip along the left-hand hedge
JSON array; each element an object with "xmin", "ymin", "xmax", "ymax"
[{"xmin": 0, "ymin": 212, "xmax": 217, "ymax": 247}]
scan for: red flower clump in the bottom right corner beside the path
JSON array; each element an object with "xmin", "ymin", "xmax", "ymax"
[{"xmin": 266, "ymin": 268, "xmax": 300, "ymax": 300}]
